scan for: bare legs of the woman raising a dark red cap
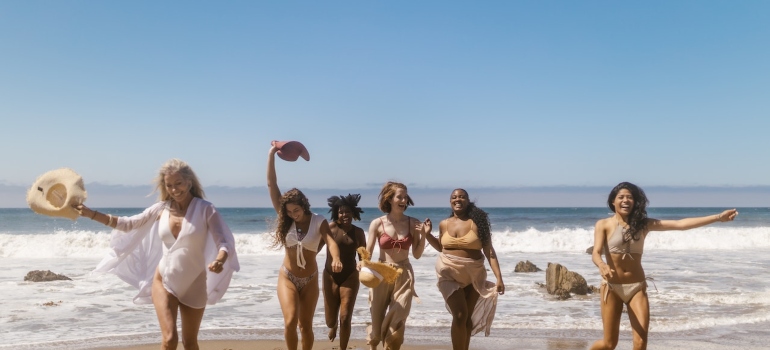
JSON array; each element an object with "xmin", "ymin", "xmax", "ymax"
[{"xmin": 278, "ymin": 271, "xmax": 320, "ymax": 350}]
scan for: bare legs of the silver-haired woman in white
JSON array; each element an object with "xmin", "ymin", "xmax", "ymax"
[{"xmin": 152, "ymin": 272, "xmax": 205, "ymax": 350}]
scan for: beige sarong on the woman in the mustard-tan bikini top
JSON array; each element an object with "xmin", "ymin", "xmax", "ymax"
[{"xmin": 436, "ymin": 253, "xmax": 497, "ymax": 336}]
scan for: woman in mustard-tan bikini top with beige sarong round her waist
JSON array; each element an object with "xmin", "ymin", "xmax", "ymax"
[{"xmin": 426, "ymin": 188, "xmax": 505, "ymax": 350}]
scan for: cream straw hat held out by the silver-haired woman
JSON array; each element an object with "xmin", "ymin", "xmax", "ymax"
[{"xmin": 27, "ymin": 168, "xmax": 88, "ymax": 220}]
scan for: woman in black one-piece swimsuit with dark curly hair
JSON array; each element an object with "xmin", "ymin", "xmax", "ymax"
[{"xmin": 321, "ymin": 194, "xmax": 366, "ymax": 349}]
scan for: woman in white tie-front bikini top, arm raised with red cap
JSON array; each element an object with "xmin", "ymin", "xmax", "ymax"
[{"xmin": 267, "ymin": 146, "xmax": 342, "ymax": 350}]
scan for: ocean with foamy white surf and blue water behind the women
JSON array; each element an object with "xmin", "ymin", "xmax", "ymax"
[{"xmin": 0, "ymin": 208, "xmax": 770, "ymax": 349}]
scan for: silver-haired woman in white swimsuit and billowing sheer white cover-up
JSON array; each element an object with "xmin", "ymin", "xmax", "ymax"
[{"xmin": 76, "ymin": 159, "xmax": 240, "ymax": 350}]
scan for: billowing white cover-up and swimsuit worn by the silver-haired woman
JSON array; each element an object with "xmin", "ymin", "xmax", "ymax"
[{"xmin": 94, "ymin": 198, "xmax": 240, "ymax": 308}]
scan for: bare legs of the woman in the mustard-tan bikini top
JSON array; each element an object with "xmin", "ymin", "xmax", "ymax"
[{"xmin": 446, "ymin": 285, "xmax": 479, "ymax": 350}]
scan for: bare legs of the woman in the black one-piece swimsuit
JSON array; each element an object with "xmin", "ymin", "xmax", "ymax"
[{"xmin": 323, "ymin": 270, "xmax": 360, "ymax": 349}]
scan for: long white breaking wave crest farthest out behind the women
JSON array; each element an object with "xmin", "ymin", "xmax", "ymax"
[{"xmin": 0, "ymin": 226, "xmax": 770, "ymax": 258}]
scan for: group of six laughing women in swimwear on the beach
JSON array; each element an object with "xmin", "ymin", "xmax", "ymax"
[{"xmin": 75, "ymin": 146, "xmax": 738, "ymax": 350}]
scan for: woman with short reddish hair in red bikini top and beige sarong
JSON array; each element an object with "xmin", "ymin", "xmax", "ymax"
[{"xmin": 366, "ymin": 182, "xmax": 432, "ymax": 350}]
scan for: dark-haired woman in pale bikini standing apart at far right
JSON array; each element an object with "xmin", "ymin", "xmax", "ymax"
[{"xmin": 591, "ymin": 182, "xmax": 738, "ymax": 350}]
